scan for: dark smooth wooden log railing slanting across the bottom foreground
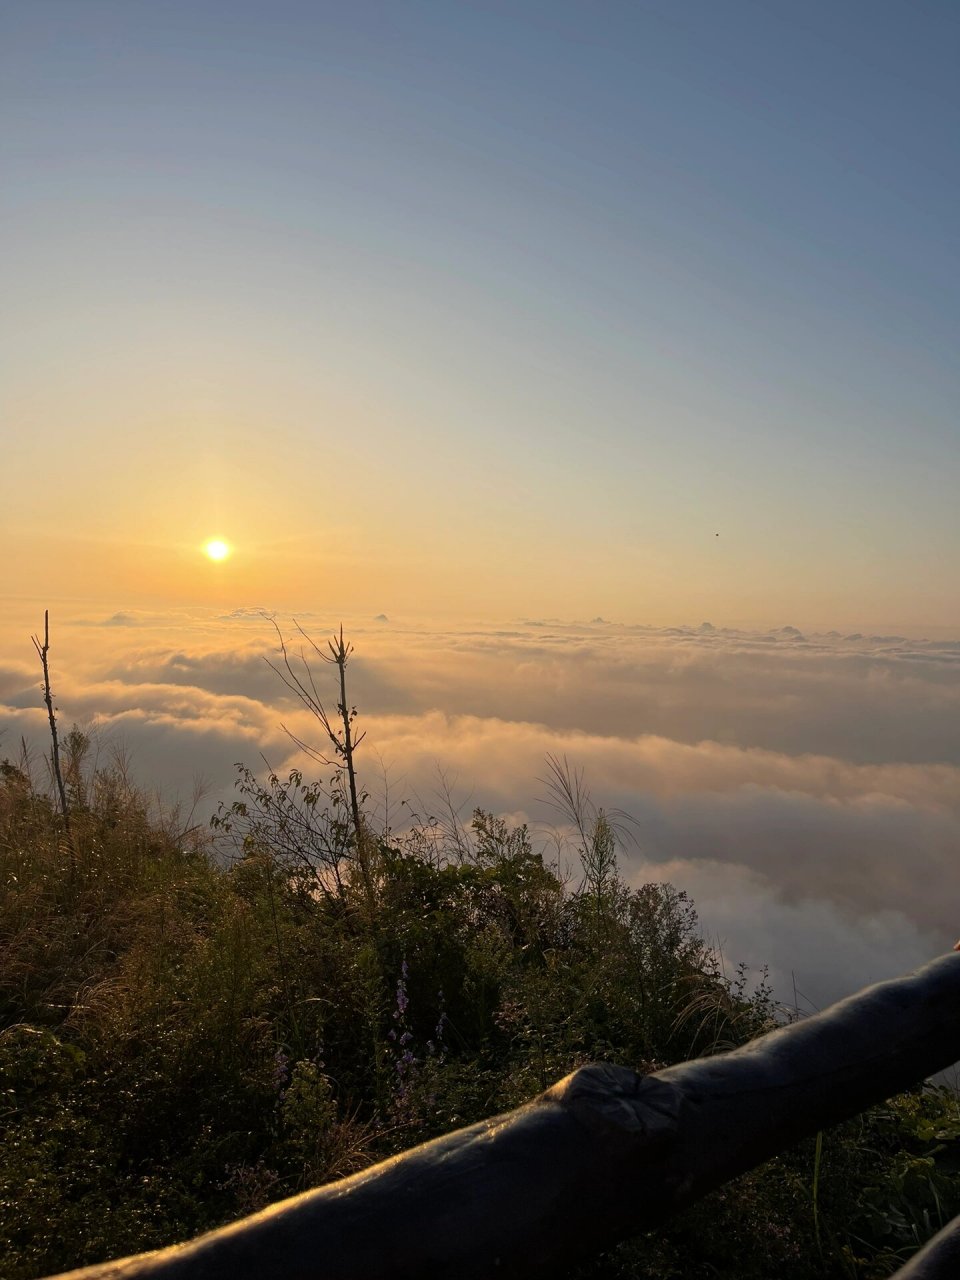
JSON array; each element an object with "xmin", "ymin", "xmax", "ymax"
[{"xmin": 45, "ymin": 954, "xmax": 960, "ymax": 1280}]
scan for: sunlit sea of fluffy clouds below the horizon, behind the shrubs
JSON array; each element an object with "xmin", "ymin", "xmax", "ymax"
[{"xmin": 0, "ymin": 608, "xmax": 960, "ymax": 1010}]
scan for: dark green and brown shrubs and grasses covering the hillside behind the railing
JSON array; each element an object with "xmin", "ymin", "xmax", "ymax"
[{"xmin": 0, "ymin": 641, "xmax": 960, "ymax": 1280}]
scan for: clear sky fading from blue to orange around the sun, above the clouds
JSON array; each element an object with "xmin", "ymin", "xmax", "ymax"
[{"xmin": 0, "ymin": 0, "xmax": 960, "ymax": 630}]
